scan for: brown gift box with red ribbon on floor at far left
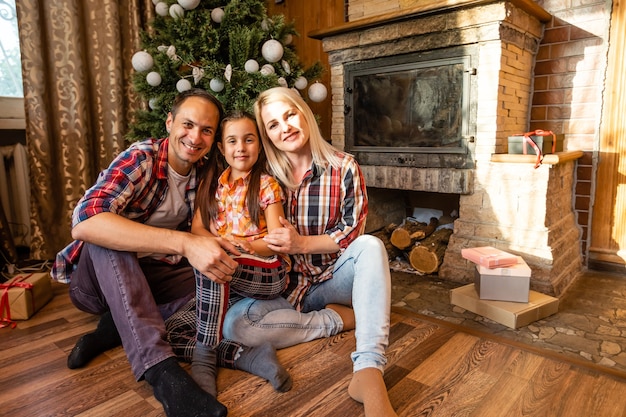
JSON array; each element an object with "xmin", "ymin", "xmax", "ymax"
[{"xmin": 0, "ymin": 272, "xmax": 52, "ymax": 327}]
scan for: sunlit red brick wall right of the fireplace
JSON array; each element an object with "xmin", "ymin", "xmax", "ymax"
[{"xmin": 530, "ymin": 0, "xmax": 612, "ymax": 254}]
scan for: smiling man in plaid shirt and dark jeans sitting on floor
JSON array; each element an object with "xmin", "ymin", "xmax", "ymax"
[{"xmin": 52, "ymin": 89, "xmax": 276, "ymax": 417}]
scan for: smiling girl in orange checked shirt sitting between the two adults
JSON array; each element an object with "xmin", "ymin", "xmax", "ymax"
[{"xmin": 191, "ymin": 112, "xmax": 291, "ymax": 395}]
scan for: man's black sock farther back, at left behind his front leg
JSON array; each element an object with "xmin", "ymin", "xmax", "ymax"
[{"xmin": 67, "ymin": 311, "xmax": 122, "ymax": 369}]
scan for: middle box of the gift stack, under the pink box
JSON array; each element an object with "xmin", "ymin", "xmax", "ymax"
[{"xmin": 474, "ymin": 256, "xmax": 531, "ymax": 303}]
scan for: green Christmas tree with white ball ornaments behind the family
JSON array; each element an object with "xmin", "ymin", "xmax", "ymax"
[{"xmin": 127, "ymin": 0, "xmax": 327, "ymax": 141}]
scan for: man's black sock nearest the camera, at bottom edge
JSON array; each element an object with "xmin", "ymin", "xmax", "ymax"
[{"xmin": 144, "ymin": 357, "xmax": 228, "ymax": 417}]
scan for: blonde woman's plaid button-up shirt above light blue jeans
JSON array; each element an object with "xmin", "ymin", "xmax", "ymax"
[{"xmin": 283, "ymin": 153, "xmax": 367, "ymax": 310}]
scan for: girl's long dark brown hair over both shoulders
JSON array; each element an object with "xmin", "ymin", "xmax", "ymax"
[{"xmin": 196, "ymin": 110, "xmax": 268, "ymax": 229}]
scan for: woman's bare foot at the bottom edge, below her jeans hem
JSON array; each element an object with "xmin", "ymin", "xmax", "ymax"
[{"xmin": 348, "ymin": 368, "xmax": 398, "ymax": 417}]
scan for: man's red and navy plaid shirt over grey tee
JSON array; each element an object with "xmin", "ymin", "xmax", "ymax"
[{"xmin": 50, "ymin": 138, "xmax": 196, "ymax": 283}]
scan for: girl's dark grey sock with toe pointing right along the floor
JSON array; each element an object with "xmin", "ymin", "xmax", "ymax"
[{"xmin": 235, "ymin": 343, "xmax": 293, "ymax": 392}]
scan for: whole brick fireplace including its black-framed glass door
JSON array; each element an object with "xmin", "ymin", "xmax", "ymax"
[{"xmin": 309, "ymin": 0, "xmax": 582, "ymax": 295}]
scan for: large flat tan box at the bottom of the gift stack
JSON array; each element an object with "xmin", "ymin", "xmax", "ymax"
[{"xmin": 450, "ymin": 284, "xmax": 559, "ymax": 329}]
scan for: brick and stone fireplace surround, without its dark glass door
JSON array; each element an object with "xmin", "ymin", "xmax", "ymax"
[{"xmin": 309, "ymin": 0, "xmax": 582, "ymax": 295}]
